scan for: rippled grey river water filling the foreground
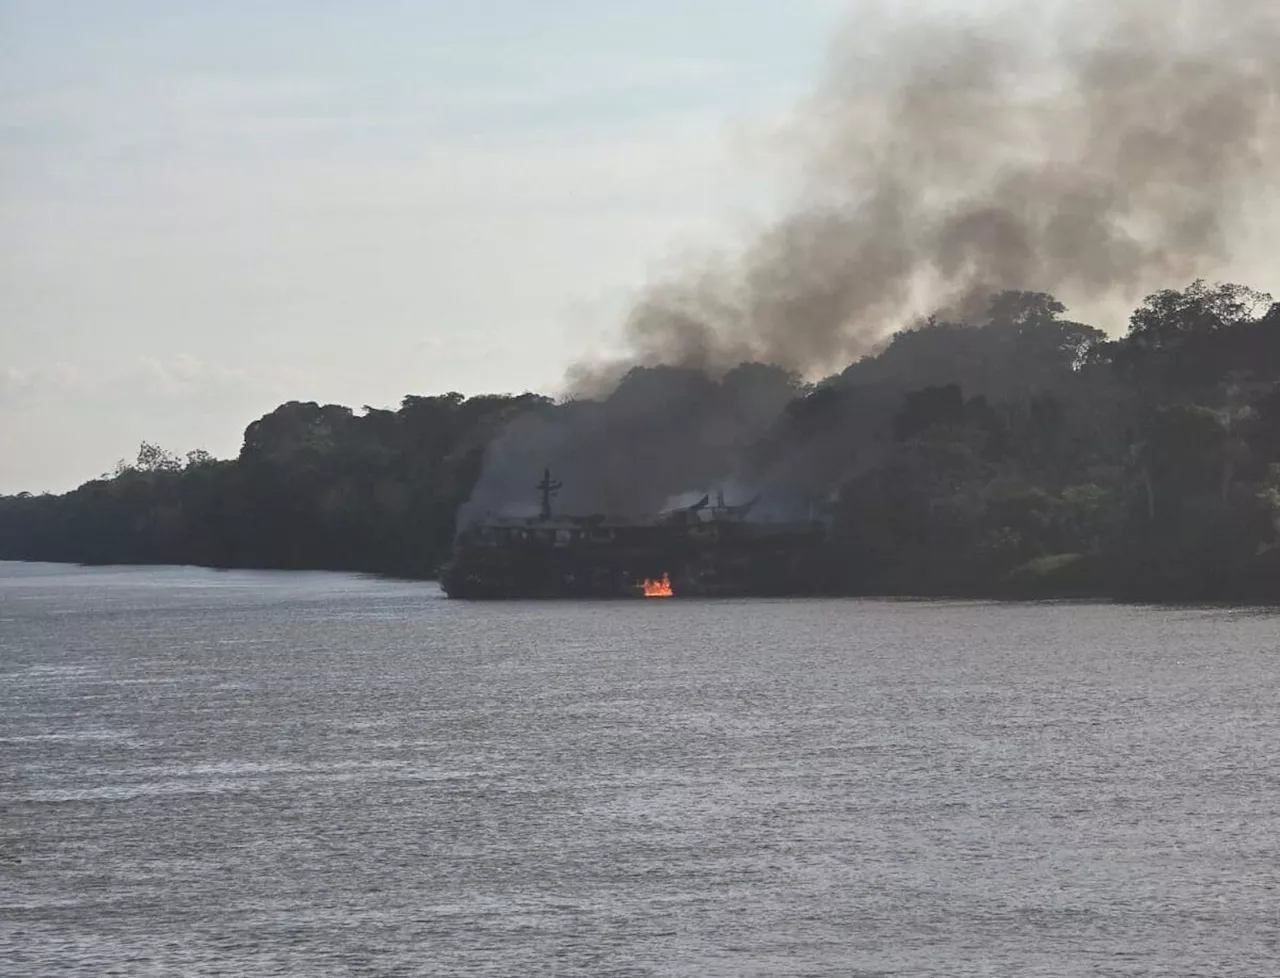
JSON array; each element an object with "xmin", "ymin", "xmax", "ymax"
[{"xmin": 0, "ymin": 565, "xmax": 1280, "ymax": 978}]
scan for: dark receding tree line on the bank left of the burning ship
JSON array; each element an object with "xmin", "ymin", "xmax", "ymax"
[{"xmin": 0, "ymin": 394, "xmax": 545, "ymax": 576}]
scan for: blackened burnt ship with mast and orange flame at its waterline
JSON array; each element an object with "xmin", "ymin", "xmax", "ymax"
[{"xmin": 440, "ymin": 470, "xmax": 826, "ymax": 598}]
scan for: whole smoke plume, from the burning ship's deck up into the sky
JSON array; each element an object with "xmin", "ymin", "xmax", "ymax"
[{"xmin": 461, "ymin": 0, "xmax": 1280, "ymax": 522}]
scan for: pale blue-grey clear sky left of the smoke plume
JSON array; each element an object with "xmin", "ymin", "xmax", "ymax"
[{"xmin": 0, "ymin": 0, "xmax": 849, "ymax": 492}]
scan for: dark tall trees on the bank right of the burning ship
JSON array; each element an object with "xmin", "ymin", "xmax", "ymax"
[{"xmin": 814, "ymin": 275, "xmax": 1280, "ymax": 600}]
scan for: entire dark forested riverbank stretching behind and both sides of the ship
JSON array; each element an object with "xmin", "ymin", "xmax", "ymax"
[{"xmin": 0, "ymin": 282, "xmax": 1280, "ymax": 603}]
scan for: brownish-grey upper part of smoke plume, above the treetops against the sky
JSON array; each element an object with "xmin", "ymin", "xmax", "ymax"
[{"xmin": 570, "ymin": 0, "xmax": 1280, "ymax": 381}]
